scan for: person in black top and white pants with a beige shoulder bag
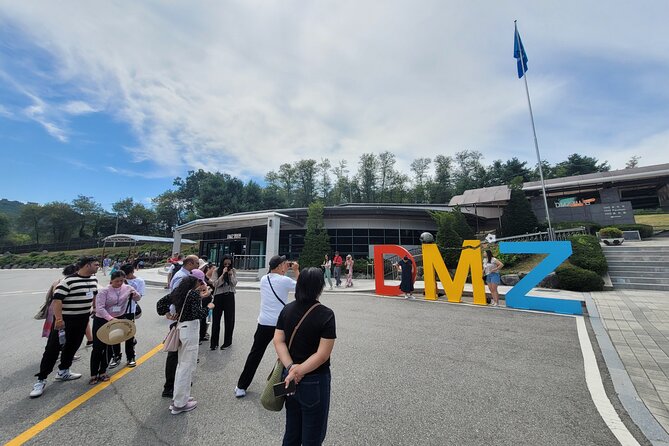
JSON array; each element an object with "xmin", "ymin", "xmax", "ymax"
[{"xmin": 164, "ymin": 276, "xmax": 208, "ymax": 415}]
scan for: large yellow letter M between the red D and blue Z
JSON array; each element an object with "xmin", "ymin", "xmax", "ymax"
[{"xmin": 423, "ymin": 240, "xmax": 486, "ymax": 305}]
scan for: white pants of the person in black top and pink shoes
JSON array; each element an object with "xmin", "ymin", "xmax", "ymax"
[{"xmin": 174, "ymin": 320, "xmax": 200, "ymax": 407}]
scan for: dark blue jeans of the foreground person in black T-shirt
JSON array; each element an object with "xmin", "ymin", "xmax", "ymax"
[{"xmin": 283, "ymin": 371, "xmax": 331, "ymax": 446}]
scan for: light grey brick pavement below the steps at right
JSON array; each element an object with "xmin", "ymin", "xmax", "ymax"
[{"xmin": 591, "ymin": 290, "xmax": 669, "ymax": 431}]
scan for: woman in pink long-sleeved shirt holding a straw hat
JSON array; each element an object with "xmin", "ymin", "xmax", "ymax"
[{"xmin": 88, "ymin": 271, "xmax": 141, "ymax": 384}]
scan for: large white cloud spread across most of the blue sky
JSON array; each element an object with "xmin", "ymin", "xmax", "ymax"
[{"xmin": 0, "ymin": 0, "xmax": 669, "ymax": 177}]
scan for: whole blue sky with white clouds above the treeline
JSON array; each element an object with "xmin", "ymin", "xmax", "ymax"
[{"xmin": 0, "ymin": 0, "xmax": 669, "ymax": 209}]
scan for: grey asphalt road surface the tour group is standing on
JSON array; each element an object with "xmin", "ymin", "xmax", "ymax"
[{"xmin": 0, "ymin": 270, "xmax": 644, "ymax": 445}]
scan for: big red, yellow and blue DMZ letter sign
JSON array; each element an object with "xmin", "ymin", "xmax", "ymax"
[{"xmin": 374, "ymin": 240, "xmax": 583, "ymax": 314}]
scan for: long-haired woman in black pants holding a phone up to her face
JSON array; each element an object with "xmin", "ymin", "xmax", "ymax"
[{"xmin": 209, "ymin": 255, "xmax": 237, "ymax": 350}]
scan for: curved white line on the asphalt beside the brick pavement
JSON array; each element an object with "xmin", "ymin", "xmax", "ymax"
[{"xmin": 576, "ymin": 316, "xmax": 639, "ymax": 446}]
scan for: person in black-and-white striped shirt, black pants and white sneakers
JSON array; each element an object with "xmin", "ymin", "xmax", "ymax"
[{"xmin": 30, "ymin": 257, "xmax": 100, "ymax": 398}]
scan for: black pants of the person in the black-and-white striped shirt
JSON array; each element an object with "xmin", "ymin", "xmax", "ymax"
[{"xmin": 36, "ymin": 314, "xmax": 89, "ymax": 379}]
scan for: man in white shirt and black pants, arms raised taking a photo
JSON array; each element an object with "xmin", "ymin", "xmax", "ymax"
[{"xmin": 235, "ymin": 255, "xmax": 300, "ymax": 398}]
